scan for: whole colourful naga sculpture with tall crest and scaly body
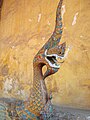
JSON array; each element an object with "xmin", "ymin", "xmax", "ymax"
[{"xmin": 0, "ymin": 0, "xmax": 69, "ymax": 120}]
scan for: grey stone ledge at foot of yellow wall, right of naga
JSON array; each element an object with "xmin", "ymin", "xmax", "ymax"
[{"xmin": 41, "ymin": 106, "xmax": 90, "ymax": 120}]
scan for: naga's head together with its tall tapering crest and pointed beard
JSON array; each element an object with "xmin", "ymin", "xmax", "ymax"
[{"xmin": 33, "ymin": 0, "xmax": 66, "ymax": 79}]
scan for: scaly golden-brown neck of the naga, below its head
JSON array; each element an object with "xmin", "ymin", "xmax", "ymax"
[{"xmin": 30, "ymin": 64, "xmax": 48, "ymax": 114}]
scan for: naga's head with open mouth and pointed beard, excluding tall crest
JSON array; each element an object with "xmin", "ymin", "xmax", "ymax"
[{"xmin": 34, "ymin": 42, "xmax": 66, "ymax": 79}]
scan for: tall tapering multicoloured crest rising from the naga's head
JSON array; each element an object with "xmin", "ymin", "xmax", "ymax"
[{"xmin": 38, "ymin": 0, "xmax": 63, "ymax": 53}]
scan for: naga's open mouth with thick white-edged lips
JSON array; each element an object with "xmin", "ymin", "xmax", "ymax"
[{"xmin": 45, "ymin": 51, "xmax": 63, "ymax": 69}]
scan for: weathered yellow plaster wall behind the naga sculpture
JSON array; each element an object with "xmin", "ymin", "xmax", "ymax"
[{"xmin": 0, "ymin": 0, "xmax": 90, "ymax": 109}]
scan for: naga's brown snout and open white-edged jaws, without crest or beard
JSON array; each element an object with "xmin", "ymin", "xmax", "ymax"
[{"xmin": 45, "ymin": 42, "xmax": 66, "ymax": 69}]
